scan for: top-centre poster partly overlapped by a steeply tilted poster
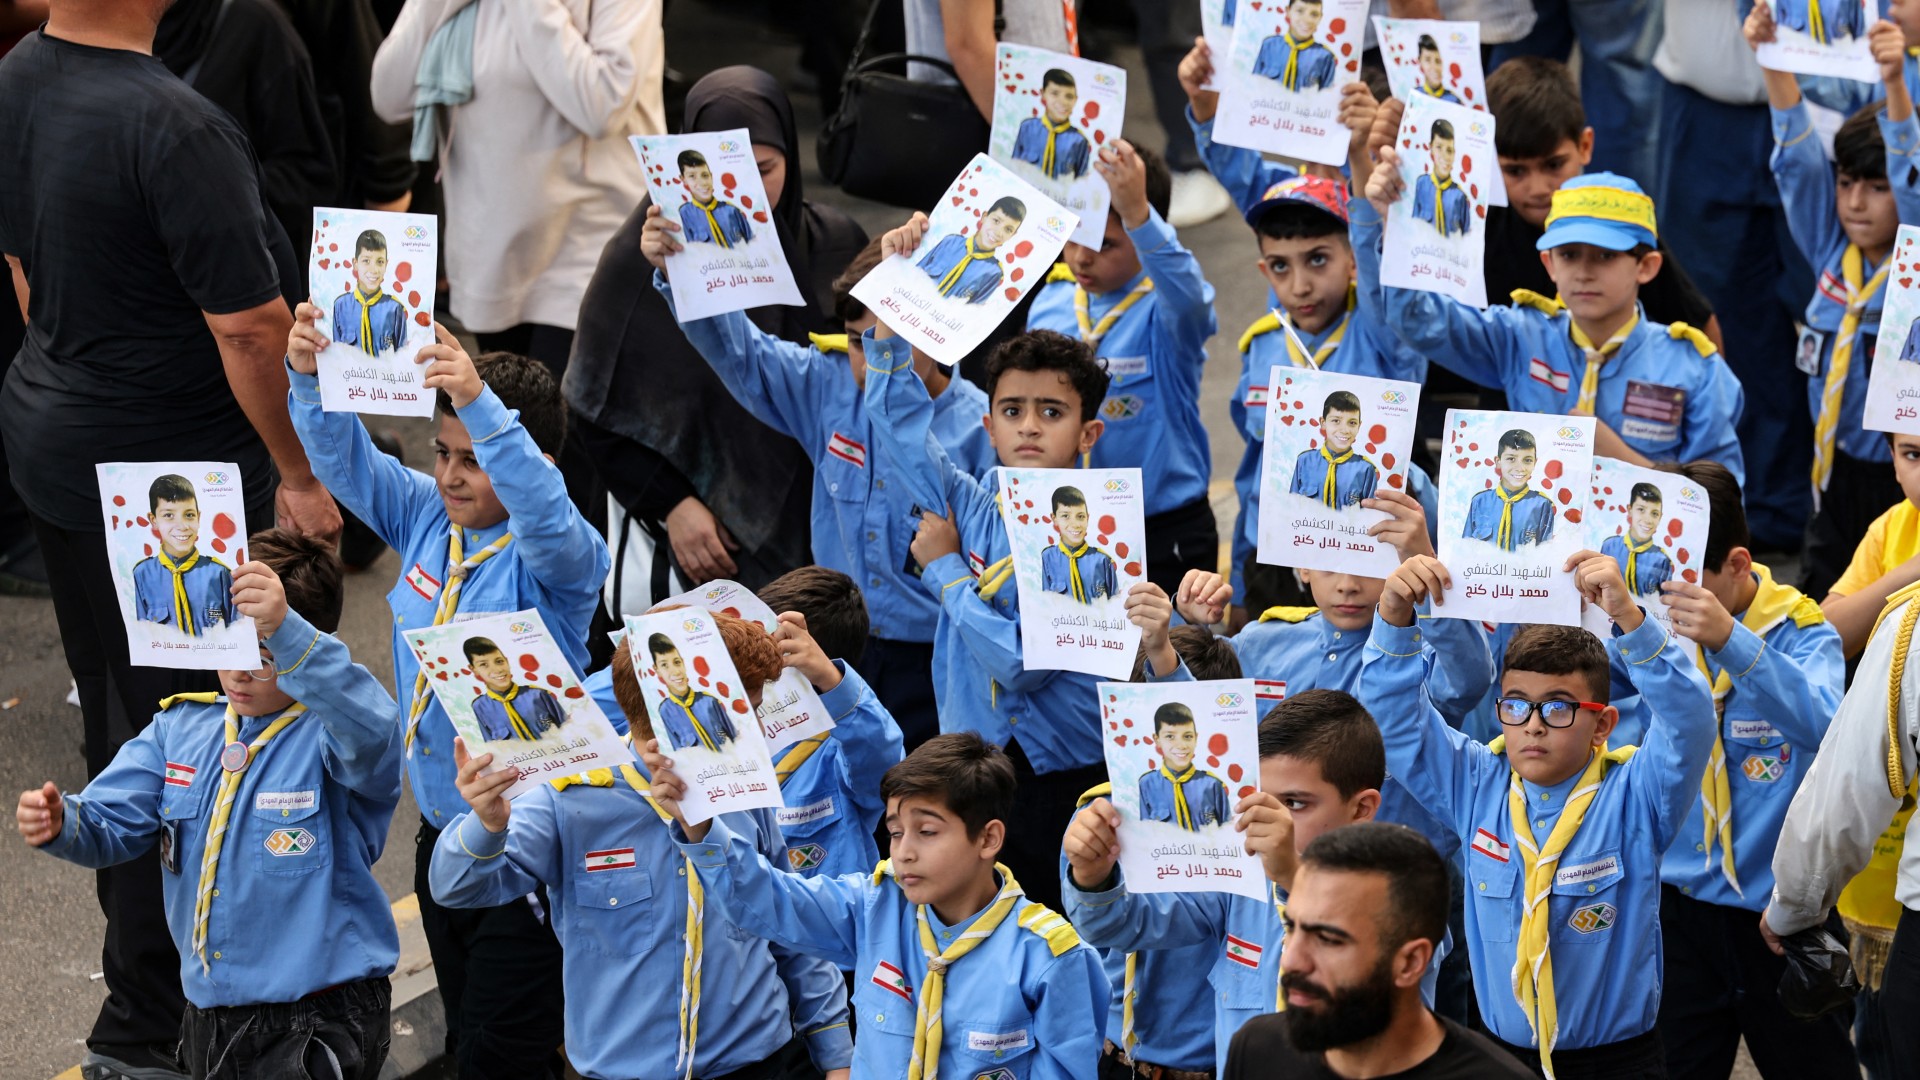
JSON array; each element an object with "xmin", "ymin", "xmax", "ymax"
[{"xmin": 987, "ymin": 42, "xmax": 1127, "ymax": 248}]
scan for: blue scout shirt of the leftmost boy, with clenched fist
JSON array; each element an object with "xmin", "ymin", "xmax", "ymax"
[{"xmin": 44, "ymin": 611, "xmax": 401, "ymax": 1009}]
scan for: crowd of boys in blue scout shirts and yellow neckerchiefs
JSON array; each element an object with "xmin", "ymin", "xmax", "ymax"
[{"xmin": 33, "ymin": 14, "xmax": 1920, "ymax": 1080}]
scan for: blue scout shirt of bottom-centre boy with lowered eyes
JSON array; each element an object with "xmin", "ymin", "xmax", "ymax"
[{"xmin": 676, "ymin": 815, "xmax": 1108, "ymax": 1080}]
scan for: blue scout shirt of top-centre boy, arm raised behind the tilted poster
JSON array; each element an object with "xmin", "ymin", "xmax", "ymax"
[{"xmin": 1027, "ymin": 211, "xmax": 1215, "ymax": 517}]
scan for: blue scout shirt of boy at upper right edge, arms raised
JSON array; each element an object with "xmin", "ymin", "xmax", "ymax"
[{"xmin": 1772, "ymin": 101, "xmax": 1920, "ymax": 461}]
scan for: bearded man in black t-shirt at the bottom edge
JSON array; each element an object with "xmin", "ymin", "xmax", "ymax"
[{"xmin": 1221, "ymin": 821, "xmax": 1532, "ymax": 1080}]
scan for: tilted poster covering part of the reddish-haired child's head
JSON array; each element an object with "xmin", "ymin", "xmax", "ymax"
[{"xmin": 626, "ymin": 607, "xmax": 785, "ymax": 824}]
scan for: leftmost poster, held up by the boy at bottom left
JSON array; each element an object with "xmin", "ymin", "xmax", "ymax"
[{"xmin": 94, "ymin": 461, "xmax": 259, "ymax": 671}]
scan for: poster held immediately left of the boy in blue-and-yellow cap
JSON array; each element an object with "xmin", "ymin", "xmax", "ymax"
[{"xmin": 1380, "ymin": 98, "xmax": 1500, "ymax": 307}]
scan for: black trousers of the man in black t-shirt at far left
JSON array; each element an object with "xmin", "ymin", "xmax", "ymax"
[{"xmin": 33, "ymin": 492, "xmax": 273, "ymax": 1065}]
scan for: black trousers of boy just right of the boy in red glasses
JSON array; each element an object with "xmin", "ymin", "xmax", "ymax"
[{"xmin": 1659, "ymin": 886, "xmax": 1860, "ymax": 1080}]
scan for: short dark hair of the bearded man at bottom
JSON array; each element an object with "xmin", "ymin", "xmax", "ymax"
[{"xmin": 1300, "ymin": 821, "xmax": 1452, "ymax": 951}]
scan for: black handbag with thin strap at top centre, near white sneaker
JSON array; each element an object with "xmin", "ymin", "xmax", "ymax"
[{"xmin": 816, "ymin": 0, "xmax": 998, "ymax": 209}]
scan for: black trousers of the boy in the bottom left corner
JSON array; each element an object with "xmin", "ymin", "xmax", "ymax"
[{"xmin": 180, "ymin": 976, "xmax": 394, "ymax": 1080}]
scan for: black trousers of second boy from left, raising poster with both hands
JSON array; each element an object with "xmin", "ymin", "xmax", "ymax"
[{"xmin": 413, "ymin": 821, "xmax": 566, "ymax": 1080}]
